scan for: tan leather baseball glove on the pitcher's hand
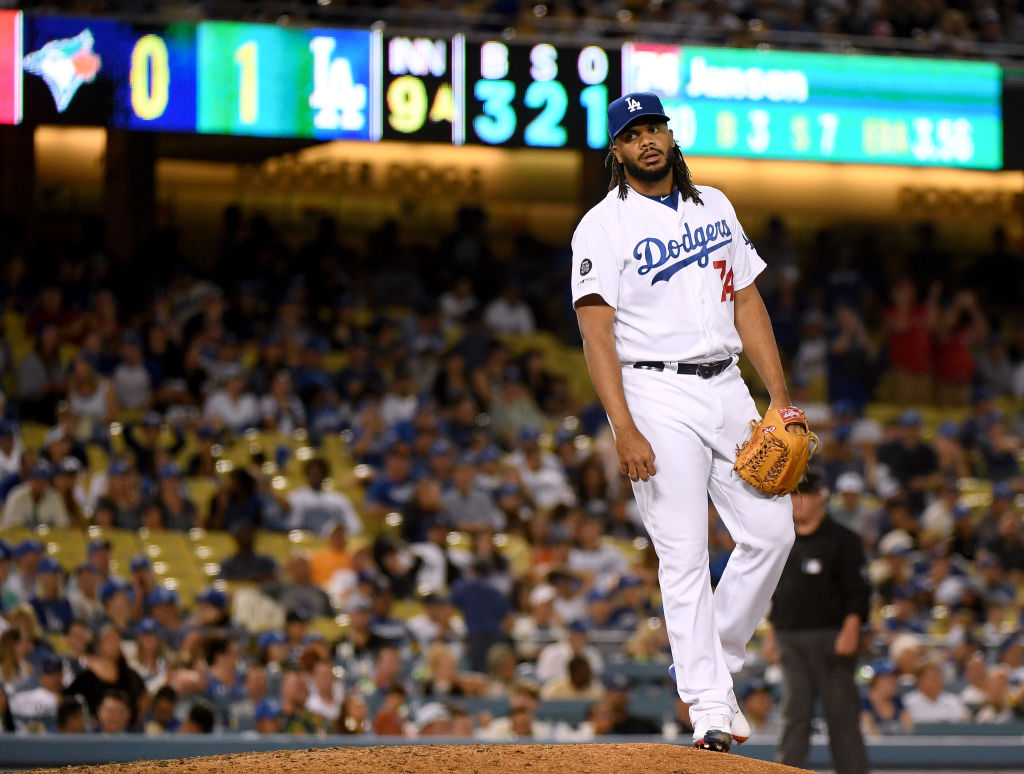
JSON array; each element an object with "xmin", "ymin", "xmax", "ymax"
[{"xmin": 732, "ymin": 405, "xmax": 818, "ymax": 495}]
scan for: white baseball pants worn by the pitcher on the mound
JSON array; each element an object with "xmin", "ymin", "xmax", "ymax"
[{"xmin": 623, "ymin": 366, "xmax": 795, "ymax": 723}]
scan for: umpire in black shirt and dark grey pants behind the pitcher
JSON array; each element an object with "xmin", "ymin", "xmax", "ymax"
[{"xmin": 766, "ymin": 471, "xmax": 870, "ymax": 774}]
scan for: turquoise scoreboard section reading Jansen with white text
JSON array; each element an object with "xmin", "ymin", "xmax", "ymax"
[{"xmin": 624, "ymin": 43, "xmax": 1002, "ymax": 169}]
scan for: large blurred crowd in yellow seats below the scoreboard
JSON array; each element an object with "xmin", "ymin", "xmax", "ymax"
[{"xmin": 0, "ymin": 202, "xmax": 1024, "ymax": 739}]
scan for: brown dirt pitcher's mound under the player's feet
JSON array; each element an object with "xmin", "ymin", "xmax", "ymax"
[{"xmin": 29, "ymin": 744, "xmax": 804, "ymax": 774}]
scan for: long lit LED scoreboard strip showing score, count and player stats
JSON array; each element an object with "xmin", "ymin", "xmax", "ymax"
[{"xmin": 0, "ymin": 10, "xmax": 1002, "ymax": 169}]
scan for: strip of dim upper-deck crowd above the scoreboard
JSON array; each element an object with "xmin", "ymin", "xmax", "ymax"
[{"xmin": 8, "ymin": 0, "xmax": 1024, "ymax": 51}]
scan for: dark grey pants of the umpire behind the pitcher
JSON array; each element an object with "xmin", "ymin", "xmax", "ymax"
[{"xmin": 775, "ymin": 629, "xmax": 868, "ymax": 774}]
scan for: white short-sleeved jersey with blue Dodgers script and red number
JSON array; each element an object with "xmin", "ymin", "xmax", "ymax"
[{"xmin": 571, "ymin": 185, "xmax": 765, "ymax": 362}]
